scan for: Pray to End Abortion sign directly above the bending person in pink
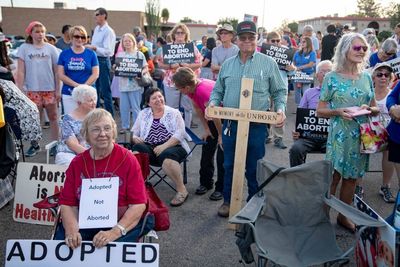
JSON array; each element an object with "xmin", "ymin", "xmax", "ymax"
[{"xmin": 163, "ymin": 43, "xmax": 195, "ymax": 64}]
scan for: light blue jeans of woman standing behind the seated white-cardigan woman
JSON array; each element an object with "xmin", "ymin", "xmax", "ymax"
[{"xmin": 119, "ymin": 90, "xmax": 142, "ymax": 129}]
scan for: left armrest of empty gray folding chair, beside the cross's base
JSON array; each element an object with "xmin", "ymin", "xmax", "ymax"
[{"xmin": 229, "ymin": 193, "xmax": 265, "ymax": 224}]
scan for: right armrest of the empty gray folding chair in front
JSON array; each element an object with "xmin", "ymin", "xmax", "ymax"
[{"xmin": 324, "ymin": 196, "xmax": 386, "ymax": 227}]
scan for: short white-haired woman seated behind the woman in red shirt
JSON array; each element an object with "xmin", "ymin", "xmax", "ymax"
[{"xmin": 55, "ymin": 85, "xmax": 97, "ymax": 166}]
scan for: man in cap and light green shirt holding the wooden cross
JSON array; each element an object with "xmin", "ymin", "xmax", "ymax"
[{"xmin": 209, "ymin": 21, "xmax": 287, "ymax": 217}]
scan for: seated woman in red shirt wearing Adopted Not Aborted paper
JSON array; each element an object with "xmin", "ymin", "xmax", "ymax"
[{"xmin": 55, "ymin": 109, "xmax": 154, "ymax": 248}]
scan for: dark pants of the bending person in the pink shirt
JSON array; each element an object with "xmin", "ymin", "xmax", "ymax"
[{"xmin": 199, "ymin": 121, "xmax": 224, "ymax": 192}]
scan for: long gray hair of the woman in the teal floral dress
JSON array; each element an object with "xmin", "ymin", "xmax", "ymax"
[{"xmin": 332, "ymin": 32, "xmax": 370, "ymax": 73}]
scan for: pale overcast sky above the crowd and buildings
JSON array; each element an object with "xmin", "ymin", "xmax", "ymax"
[{"xmin": 0, "ymin": 0, "xmax": 398, "ymax": 30}]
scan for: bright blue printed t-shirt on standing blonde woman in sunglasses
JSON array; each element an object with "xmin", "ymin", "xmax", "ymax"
[{"xmin": 57, "ymin": 48, "xmax": 99, "ymax": 95}]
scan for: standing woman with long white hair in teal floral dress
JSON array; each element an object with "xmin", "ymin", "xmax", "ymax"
[{"xmin": 317, "ymin": 33, "xmax": 379, "ymax": 232}]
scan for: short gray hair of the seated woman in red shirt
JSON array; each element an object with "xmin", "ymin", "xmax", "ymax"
[{"xmin": 81, "ymin": 108, "xmax": 118, "ymax": 145}]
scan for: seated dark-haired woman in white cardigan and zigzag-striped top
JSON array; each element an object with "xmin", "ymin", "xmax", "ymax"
[{"xmin": 131, "ymin": 88, "xmax": 190, "ymax": 207}]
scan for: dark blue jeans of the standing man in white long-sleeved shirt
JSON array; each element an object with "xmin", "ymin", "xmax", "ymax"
[{"xmin": 96, "ymin": 57, "xmax": 114, "ymax": 116}]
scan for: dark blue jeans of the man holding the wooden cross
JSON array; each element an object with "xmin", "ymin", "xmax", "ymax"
[{"xmin": 222, "ymin": 121, "xmax": 267, "ymax": 203}]
